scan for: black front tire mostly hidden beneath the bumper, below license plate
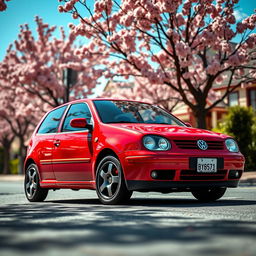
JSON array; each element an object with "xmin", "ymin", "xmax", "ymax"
[{"xmin": 191, "ymin": 188, "xmax": 227, "ymax": 202}]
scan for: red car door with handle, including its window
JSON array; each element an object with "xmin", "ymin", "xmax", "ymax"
[{"xmin": 52, "ymin": 102, "xmax": 92, "ymax": 182}]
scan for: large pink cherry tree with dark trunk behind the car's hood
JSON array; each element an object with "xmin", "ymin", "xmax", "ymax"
[{"xmin": 59, "ymin": 0, "xmax": 256, "ymax": 128}]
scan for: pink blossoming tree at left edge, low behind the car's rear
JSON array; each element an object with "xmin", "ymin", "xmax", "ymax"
[{"xmin": 0, "ymin": 81, "xmax": 44, "ymax": 173}]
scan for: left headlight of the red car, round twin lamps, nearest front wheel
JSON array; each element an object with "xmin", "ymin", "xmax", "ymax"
[{"xmin": 143, "ymin": 135, "xmax": 171, "ymax": 151}]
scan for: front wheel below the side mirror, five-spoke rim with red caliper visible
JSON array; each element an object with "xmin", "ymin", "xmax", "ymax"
[{"xmin": 96, "ymin": 156, "xmax": 132, "ymax": 204}]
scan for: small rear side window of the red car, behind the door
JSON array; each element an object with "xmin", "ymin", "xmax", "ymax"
[{"xmin": 37, "ymin": 106, "xmax": 67, "ymax": 134}]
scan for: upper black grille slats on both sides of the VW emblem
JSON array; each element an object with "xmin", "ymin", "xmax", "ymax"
[{"xmin": 174, "ymin": 140, "xmax": 224, "ymax": 150}]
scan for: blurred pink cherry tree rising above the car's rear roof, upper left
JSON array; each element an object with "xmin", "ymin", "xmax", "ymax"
[{"xmin": 0, "ymin": 17, "xmax": 102, "ymax": 107}]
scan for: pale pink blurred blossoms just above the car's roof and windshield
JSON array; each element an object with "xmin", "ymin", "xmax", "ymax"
[{"xmin": 100, "ymin": 77, "xmax": 181, "ymax": 112}]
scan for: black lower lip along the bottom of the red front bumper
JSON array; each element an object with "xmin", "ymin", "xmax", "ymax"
[{"xmin": 126, "ymin": 180, "xmax": 239, "ymax": 192}]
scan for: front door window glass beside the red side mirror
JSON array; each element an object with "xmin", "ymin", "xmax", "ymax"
[{"xmin": 62, "ymin": 103, "xmax": 92, "ymax": 132}]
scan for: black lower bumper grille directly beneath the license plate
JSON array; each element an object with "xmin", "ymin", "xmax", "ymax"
[{"xmin": 180, "ymin": 170, "xmax": 227, "ymax": 180}]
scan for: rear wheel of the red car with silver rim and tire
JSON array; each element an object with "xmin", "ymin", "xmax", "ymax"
[{"xmin": 24, "ymin": 164, "xmax": 48, "ymax": 202}]
